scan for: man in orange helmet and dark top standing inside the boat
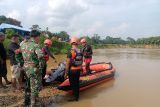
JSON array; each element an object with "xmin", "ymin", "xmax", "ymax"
[{"xmin": 80, "ymin": 38, "xmax": 93, "ymax": 74}]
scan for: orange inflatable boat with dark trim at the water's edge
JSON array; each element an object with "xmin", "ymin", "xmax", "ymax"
[{"xmin": 58, "ymin": 62, "xmax": 115, "ymax": 92}]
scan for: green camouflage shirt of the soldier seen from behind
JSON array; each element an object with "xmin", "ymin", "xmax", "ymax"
[{"xmin": 20, "ymin": 40, "xmax": 44, "ymax": 67}]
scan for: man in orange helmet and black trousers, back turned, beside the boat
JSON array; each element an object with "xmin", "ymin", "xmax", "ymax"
[{"xmin": 66, "ymin": 37, "xmax": 83, "ymax": 101}]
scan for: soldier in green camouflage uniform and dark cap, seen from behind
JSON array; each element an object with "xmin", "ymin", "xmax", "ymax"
[{"xmin": 20, "ymin": 30, "xmax": 44, "ymax": 106}]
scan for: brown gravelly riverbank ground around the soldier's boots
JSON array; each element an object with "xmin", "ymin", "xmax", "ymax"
[{"xmin": 0, "ymin": 83, "xmax": 67, "ymax": 107}]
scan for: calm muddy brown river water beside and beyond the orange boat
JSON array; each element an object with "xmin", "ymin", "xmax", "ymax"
[{"xmin": 60, "ymin": 49, "xmax": 160, "ymax": 107}]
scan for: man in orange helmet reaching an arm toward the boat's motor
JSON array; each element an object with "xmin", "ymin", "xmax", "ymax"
[{"xmin": 42, "ymin": 39, "xmax": 57, "ymax": 86}]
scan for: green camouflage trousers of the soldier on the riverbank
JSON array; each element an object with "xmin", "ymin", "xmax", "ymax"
[{"xmin": 24, "ymin": 66, "xmax": 42, "ymax": 105}]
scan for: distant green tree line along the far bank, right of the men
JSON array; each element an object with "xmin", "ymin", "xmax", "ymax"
[{"xmin": 86, "ymin": 34, "xmax": 160, "ymax": 45}]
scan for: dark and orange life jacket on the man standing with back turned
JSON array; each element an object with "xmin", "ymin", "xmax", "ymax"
[{"xmin": 71, "ymin": 49, "xmax": 83, "ymax": 67}]
